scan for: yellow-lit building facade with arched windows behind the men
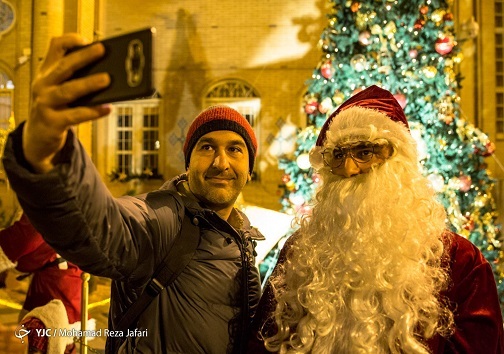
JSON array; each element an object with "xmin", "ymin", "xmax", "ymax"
[{"xmin": 0, "ymin": 0, "xmax": 504, "ymax": 213}]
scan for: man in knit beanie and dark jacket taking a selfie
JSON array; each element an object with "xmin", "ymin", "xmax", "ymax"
[{"xmin": 3, "ymin": 34, "xmax": 261, "ymax": 354}]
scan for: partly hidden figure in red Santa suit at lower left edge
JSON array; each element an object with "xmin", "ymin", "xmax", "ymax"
[{"xmin": 0, "ymin": 214, "xmax": 85, "ymax": 354}]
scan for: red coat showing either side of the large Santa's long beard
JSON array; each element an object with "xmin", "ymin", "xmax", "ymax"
[{"xmin": 248, "ymin": 232, "xmax": 504, "ymax": 354}]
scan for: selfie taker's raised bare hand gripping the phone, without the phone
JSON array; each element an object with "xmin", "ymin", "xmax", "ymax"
[{"xmin": 23, "ymin": 33, "xmax": 110, "ymax": 173}]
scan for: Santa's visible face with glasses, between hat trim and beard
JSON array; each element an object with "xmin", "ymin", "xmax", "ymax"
[{"xmin": 322, "ymin": 141, "xmax": 392, "ymax": 178}]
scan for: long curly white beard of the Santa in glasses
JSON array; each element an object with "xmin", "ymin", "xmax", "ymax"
[{"xmin": 274, "ymin": 157, "xmax": 446, "ymax": 353}]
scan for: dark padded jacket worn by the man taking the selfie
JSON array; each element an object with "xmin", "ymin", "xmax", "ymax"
[{"xmin": 3, "ymin": 125, "xmax": 260, "ymax": 354}]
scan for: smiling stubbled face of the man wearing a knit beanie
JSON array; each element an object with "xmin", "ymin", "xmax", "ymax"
[{"xmin": 187, "ymin": 130, "xmax": 249, "ymax": 210}]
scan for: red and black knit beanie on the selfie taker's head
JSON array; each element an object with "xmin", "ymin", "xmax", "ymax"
[{"xmin": 183, "ymin": 105, "xmax": 257, "ymax": 173}]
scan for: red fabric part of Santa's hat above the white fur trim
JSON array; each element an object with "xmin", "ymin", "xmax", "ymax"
[{"xmin": 315, "ymin": 85, "xmax": 409, "ymax": 146}]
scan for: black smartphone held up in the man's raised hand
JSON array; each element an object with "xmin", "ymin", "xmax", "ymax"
[{"xmin": 67, "ymin": 28, "xmax": 156, "ymax": 107}]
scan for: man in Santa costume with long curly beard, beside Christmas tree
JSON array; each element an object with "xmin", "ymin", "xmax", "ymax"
[{"xmin": 250, "ymin": 86, "xmax": 504, "ymax": 354}]
